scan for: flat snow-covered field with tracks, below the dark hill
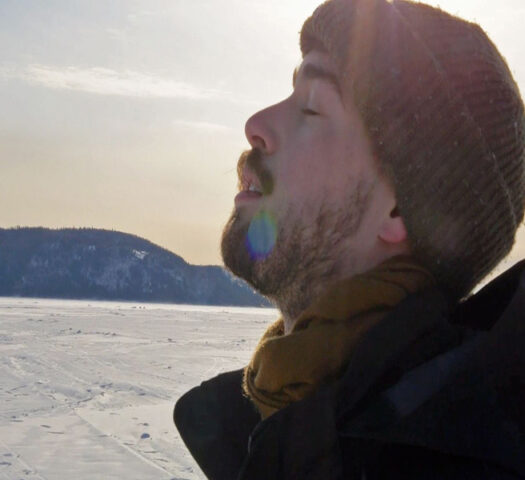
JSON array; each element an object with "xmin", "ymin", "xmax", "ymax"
[{"xmin": 0, "ymin": 298, "xmax": 277, "ymax": 480}]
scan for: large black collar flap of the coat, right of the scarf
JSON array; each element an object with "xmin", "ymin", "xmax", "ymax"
[{"xmin": 342, "ymin": 261, "xmax": 525, "ymax": 475}]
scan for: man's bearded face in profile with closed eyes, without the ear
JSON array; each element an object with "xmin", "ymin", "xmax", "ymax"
[{"xmin": 221, "ymin": 51, "xmax": 388, "ymax": 297}]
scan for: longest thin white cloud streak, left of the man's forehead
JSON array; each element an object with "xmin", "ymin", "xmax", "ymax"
[{"xmin": 10, "ymin": 65, "xmax": 233, "ymax": 100}]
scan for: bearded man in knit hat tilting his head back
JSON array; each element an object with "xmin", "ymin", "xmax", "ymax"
[{"xmin": 175, "ymin": 0, "xmax": 525, "ymax": 480}]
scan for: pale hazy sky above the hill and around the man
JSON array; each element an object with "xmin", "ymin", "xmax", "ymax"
[{"xmin": 0, "ymin": 0, "xmax": 525, "ymax": 270}]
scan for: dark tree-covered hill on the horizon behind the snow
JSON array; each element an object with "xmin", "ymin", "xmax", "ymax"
[{"xmin": 0, "ymin": 228, "xmax": 269, "ymax": 306}]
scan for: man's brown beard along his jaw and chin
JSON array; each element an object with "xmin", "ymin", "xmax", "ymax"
[{"xmin": 221, "ymin": 151, "xmax": 373, "ymax": 316}]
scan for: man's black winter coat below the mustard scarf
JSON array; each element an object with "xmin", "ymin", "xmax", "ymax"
[{"xmin": 174, "ymin": 261, "xmax": 525, "ymax": 480}]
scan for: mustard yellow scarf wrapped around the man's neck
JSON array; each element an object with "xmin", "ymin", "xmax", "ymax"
[{"xmin": 243, "ymin": 256, "xmax": 434, "ymax": 418}]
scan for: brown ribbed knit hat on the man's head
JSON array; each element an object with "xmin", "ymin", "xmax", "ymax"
[{"xmin": 301, "ymin": 0, "xmax": 525, "ymax": 299}]
